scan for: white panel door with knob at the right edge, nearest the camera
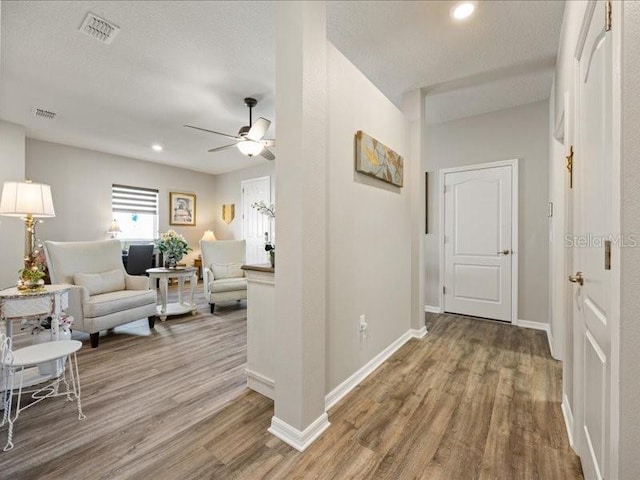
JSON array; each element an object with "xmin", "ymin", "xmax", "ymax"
[{"xmin": 571, "ymin": 1, "xmax": 616, "ymax": 480}]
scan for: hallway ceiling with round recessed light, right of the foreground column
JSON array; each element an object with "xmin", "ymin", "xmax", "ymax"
[{"xmin": 327, "ymin": 0, "xmax": 564, "ymax": 123}]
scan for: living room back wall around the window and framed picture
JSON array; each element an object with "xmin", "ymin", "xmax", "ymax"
[{"xmin": 26, "ymin": 139, "xmax": 215, "ymax": 262}]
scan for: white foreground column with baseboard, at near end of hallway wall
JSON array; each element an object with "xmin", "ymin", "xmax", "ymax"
[{"xmin": 269, "ymin": 1, "xmax": 329, "ymax": 451}]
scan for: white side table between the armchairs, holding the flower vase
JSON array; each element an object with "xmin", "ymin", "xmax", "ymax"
[{"xmin": 147, "ymin": 267, "xmax": 198, "ymax": 322}]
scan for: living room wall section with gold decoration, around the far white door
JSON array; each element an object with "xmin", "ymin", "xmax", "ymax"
[{"xmin": 213, "ymin": 164, "xmax": 276, "ymax": 240}]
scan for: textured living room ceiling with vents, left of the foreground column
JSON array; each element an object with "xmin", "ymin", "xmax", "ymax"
[{"xmin": 0, "ymin": 0, "xmax": 275, "ymax": 173}]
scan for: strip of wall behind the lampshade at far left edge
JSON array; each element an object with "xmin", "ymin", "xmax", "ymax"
[{"xmin": 0, "ymin": 121, "xmax": 26, "ymax": 289}]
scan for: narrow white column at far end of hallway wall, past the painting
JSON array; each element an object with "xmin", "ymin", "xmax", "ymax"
[{"xmin": 402, "ymin": 89, "xmax": 426, "ymax": 334}]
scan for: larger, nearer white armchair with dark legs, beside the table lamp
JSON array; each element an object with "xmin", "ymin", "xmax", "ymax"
[{"xmin": 44, "ymin": 240, "xmax": 156, "ymax": 348}]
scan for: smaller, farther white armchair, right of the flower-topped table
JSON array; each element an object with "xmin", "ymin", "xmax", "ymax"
[{"xmin": 200, "ymin": 240, "xmax": 247, "ymax": 313}]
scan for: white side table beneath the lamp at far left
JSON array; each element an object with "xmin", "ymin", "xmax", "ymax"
[{"xmin": 0, "ymin": 285, "xmax": 69, "ymax": 391}]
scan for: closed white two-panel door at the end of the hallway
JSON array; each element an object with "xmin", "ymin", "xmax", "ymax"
[{"xmin": 443, "ymin": 165, "xmax": 516, "ymax": 322}]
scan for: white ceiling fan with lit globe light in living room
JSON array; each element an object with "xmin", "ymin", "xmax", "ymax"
[{"xmin": 185, "ymin": 97, "xmax": 276, "ymax": 160}]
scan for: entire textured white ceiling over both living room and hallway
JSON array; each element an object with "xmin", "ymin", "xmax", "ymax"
[{"xmin": 0, "ymin": 0, "xmax": 563, "ymax": 173}]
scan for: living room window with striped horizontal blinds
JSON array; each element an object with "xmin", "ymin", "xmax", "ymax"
[{"xmin": 111, "ymin": 184, "xmax": 158, "ymax": 241}]
